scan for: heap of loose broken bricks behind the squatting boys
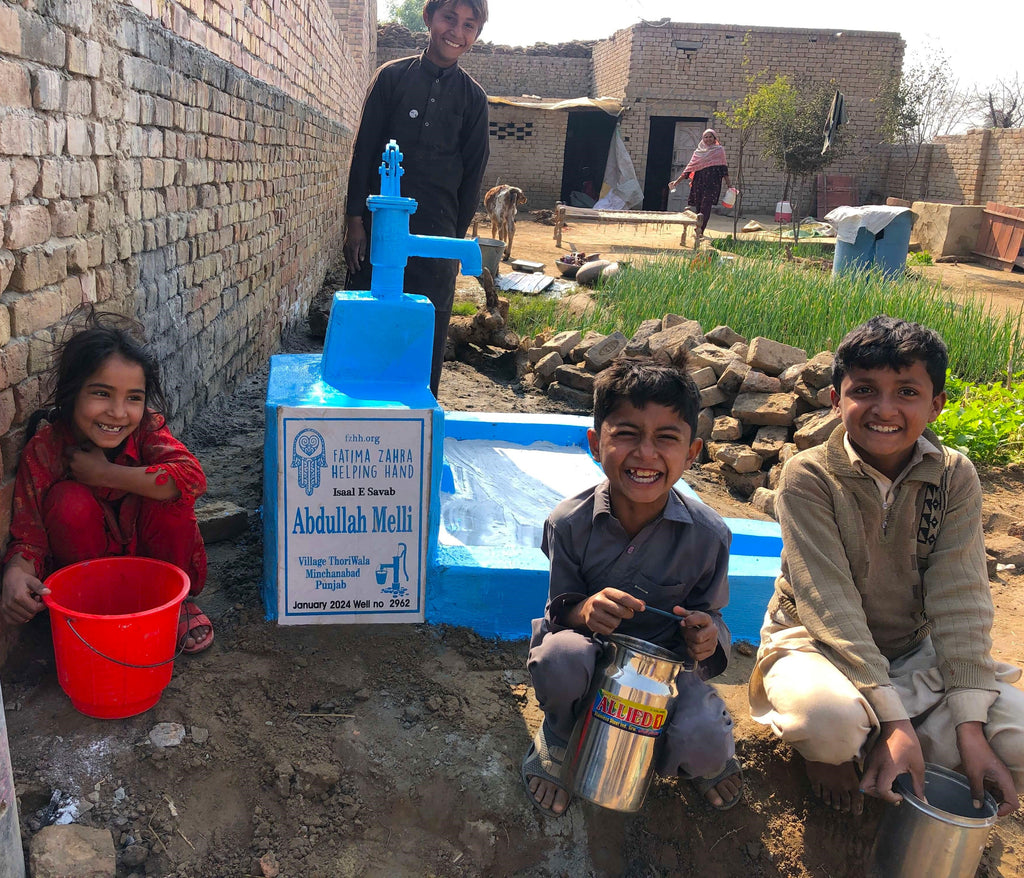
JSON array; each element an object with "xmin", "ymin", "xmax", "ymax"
[{"xmin": 523, "ymin": 315, "xmax": 839, "ymax": 514}]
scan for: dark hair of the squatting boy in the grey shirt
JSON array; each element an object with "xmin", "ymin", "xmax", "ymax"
[{"xmin": 594, "ymin": 354, "xmax": 700, "ymax": 441}]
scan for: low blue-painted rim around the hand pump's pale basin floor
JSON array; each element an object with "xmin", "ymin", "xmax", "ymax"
[{"xmin": 426, "ymin": 412, "xmax": 782, "ymax": 643}]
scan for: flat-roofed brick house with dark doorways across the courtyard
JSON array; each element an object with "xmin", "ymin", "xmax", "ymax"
[{"xmin": 378, "ymin": 20, "xmax": 904, "ymax": 212}]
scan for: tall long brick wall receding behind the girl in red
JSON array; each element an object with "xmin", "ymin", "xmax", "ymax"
[{"xmin": 0, "ymin": 0, "xmax": 370, "ymax": 532}]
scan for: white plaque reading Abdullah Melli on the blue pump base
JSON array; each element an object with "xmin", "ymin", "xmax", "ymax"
[{"xmin": 278, "ymin": 408, "xmax": 432, "ymax": 625}]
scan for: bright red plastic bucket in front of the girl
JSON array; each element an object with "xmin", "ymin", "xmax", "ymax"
[{"xmin": 43, "ymin": 556, "xmax": 188, "ymax": 719}]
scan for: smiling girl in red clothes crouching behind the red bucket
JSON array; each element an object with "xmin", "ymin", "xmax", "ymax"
[{"xmin": 0, "ymin": 310, "xmax": 213, "ymax": 653}]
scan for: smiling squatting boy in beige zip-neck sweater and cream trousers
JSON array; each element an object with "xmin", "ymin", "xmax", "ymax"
[{"xmin": 750, "ymin": 317, "xmax": 1024, "ymax": 817}]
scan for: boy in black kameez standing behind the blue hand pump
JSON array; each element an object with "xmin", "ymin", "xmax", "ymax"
[{"xmin": 345, "ymin": 0, "xmax": 488, "ymax": 396}]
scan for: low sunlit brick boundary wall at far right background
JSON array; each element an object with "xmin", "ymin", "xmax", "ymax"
[{"xmin": 889, "ymin": 128, "xmax": 1024, "ymax": 205}]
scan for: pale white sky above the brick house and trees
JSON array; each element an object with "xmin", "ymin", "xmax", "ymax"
[{"xmin": 378, "ymin": 0, "xmax": 1024, "ymax": 86}]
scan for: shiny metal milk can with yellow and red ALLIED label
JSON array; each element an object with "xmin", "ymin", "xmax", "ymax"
[{"xmin": 567, "ymin": 634, "xmax": 689, "ymax": 811}]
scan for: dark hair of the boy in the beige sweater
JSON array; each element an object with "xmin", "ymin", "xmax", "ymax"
[{"xmin": 833, "ymin": 315, "xmax": 949, "ymax": 396}]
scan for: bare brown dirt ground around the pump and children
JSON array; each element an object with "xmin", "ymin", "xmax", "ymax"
[{"xmin": 6, "ymin": 214, "xmax": 1024, "ymax": 878}]
